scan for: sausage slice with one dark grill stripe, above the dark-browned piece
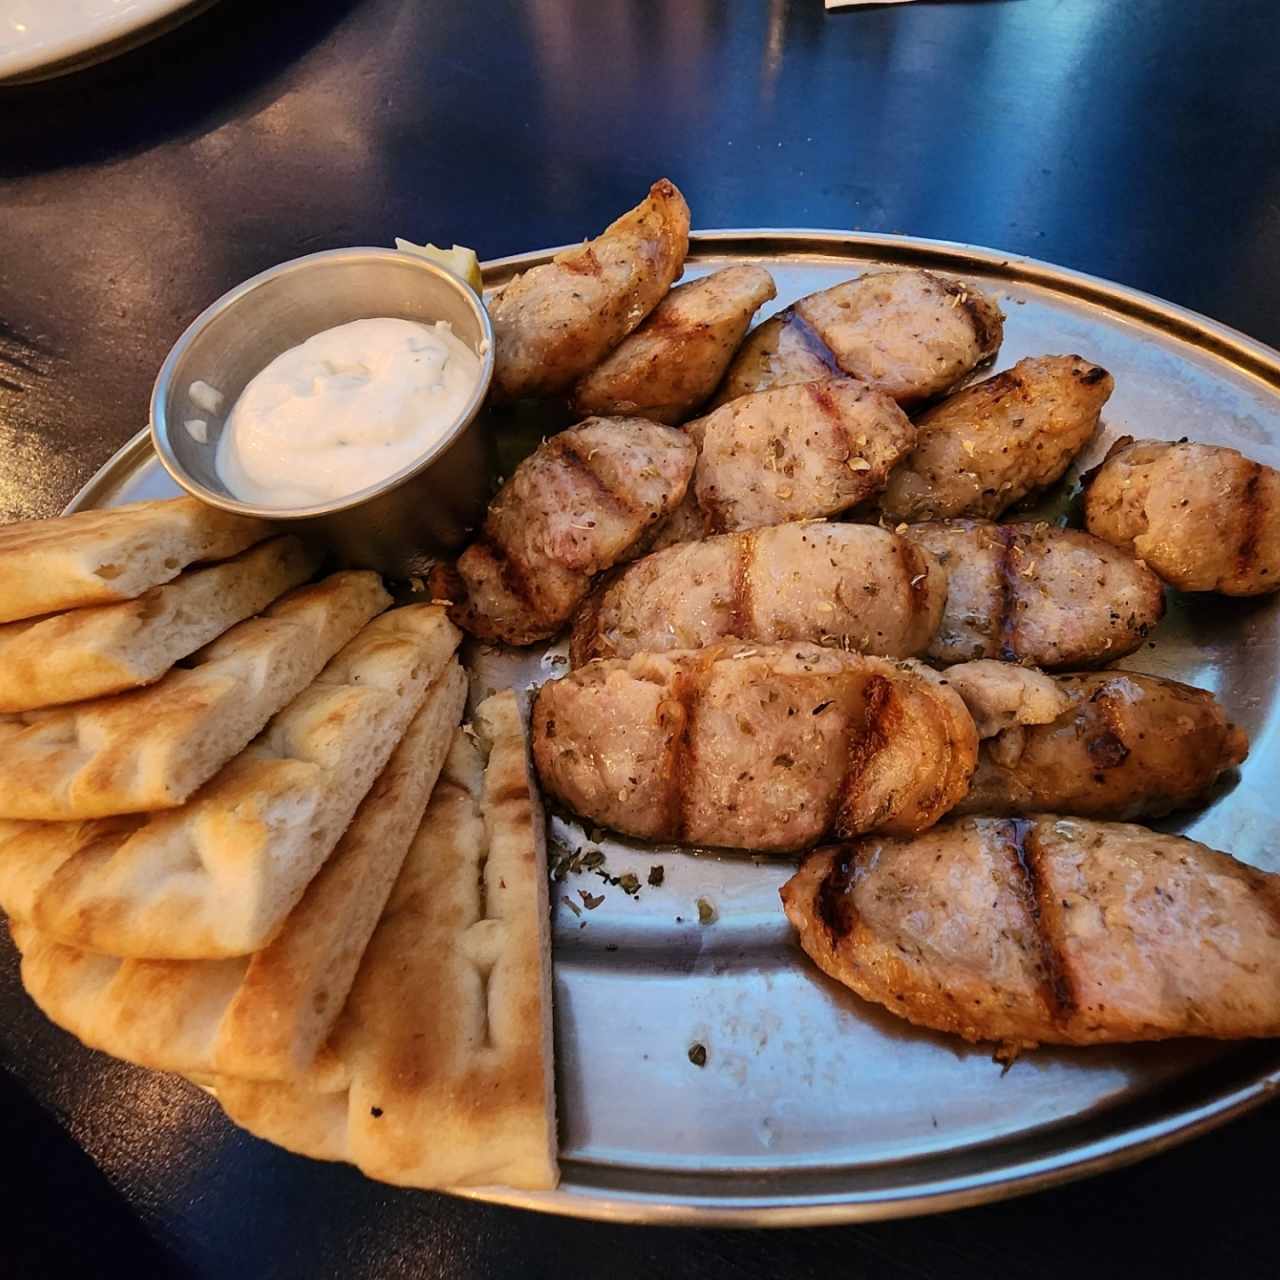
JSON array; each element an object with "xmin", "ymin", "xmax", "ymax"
[{"xmin": 899, "ymin": 520, "xmax": 1165, "ymax": 669}]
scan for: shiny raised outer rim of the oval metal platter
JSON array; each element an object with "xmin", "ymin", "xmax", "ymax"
[{"xmin": 64, "ymin": 228, "xmax": 1280, "ymax": 1228}]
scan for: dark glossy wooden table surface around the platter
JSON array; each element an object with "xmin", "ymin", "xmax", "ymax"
[{"xmin": 0, "ymin": 0, "xmax": 1280, "ymax": 1280}]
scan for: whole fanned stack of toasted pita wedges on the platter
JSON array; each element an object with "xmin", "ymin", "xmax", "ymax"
[{"xmin": 0, "ymin": 499, "xmax": 558, "ymax": 1188}]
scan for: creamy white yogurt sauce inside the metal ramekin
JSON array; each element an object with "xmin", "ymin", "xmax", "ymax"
[{"xmin": 216, "ymin": 319, "xmax": 480, "ymax": 508}]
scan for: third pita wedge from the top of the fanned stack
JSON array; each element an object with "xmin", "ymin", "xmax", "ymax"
[{"xmin": 0, "ymin": 572, "xmax": 390, "ymax": 822}]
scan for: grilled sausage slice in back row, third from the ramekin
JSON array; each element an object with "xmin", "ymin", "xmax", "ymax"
[{"xmin": 714, "ymin": 268, "xmax": 1005, "ymax": 406}]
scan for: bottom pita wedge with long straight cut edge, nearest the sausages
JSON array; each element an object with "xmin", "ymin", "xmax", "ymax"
[{"xmin": 216, "ymin": 691, "xmax": 559, "ymax": 1188}]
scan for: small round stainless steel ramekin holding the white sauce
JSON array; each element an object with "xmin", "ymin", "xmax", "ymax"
[{"xmin": 151, "ymin": 248, "xmax": 493, "ymax": 577}]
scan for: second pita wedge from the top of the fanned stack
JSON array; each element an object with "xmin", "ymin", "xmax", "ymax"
[{"xmin": 0, "ymin": 538, "xmax": 319, "ymax": 712}]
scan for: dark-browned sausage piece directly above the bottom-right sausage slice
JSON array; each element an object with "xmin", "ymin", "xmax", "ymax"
[{"xmin": 947, "ymin": 662, "xmax": 1249, "ymax": 822}]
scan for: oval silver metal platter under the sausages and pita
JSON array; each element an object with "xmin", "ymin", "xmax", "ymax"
[{"xmin": 69, "ymin": 232, "xmax": 1280, "ymax": 1226}]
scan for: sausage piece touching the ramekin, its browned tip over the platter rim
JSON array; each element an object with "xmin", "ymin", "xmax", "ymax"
[{"xmin": 489, "ymin": 178, "xmax": 689, "ymax": 401}]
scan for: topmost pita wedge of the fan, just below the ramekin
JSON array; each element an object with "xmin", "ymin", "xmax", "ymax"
[{"xmin": 0, "ymin": 498, "xmax": 271, "ymax": 622}]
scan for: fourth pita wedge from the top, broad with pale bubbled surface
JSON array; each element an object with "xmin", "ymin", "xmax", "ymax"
[{"xmin": 0, "ymin": 604, "xmax": 461, "ymax": 960}]
